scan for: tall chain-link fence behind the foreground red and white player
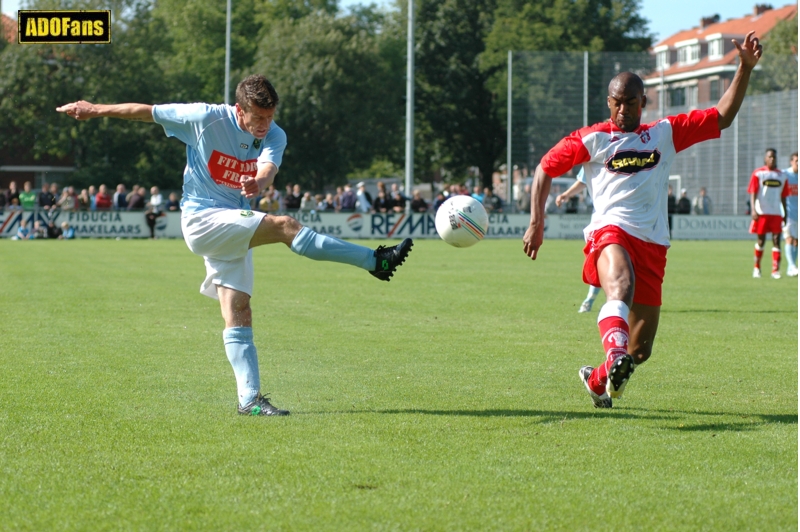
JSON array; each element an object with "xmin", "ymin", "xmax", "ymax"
[{"xmin": 510, "ymin": 52, "xmax": 798, "ymax": 214}]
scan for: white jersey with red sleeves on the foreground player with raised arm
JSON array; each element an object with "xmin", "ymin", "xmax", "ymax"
[{"xmin": 541, "ymin": 107, "xmax": 720, "ymax": 246}]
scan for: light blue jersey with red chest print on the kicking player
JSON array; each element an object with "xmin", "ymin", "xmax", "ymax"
[{"xmin": 153, "ymin": 103, "xmax": 286, "ymax": 212}]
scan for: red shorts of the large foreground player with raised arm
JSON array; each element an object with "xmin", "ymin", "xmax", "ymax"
[{"xmin": 583, "ymin": 225, "xmax": 667, "ymax": 307}]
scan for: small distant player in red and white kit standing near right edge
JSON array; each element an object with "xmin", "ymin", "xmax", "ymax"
[{"xmin": 747, "ymin": 148, "xmax": 789, "ymax": 279}]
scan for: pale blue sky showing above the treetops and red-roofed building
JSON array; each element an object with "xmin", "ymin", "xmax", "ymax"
[{"xmin": 2, "ymin": 0, "xmax": 791, "ymax": 40}]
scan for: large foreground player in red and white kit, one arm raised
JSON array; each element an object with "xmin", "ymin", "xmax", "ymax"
[{"xmin": 523, "ymin": 32, "xmax": 762, "ymax": 408}]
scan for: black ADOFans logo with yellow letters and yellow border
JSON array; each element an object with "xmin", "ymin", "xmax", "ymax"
[{"xmin": 17, "ymin": 11, "xmax": 111, "ymax": 44}]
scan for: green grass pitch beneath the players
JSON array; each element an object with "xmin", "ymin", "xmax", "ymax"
[{"xmin": 0, "ymin": 240, "xmax": 798, "ymax": 532}]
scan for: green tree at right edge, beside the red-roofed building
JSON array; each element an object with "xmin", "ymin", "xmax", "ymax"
[{"xmin": 748, "ymin": 15, "xmax": 797, "ymax": 94}]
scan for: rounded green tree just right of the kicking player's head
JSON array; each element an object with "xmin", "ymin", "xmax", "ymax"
[{"xmin": 254, "ymin": 12, "xmax": 403, "ymax": 190}]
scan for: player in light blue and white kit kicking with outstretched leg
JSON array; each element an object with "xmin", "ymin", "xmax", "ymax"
[{"xmin": 56, "ymin": 75, "xmax": 413, "ymax": 416}]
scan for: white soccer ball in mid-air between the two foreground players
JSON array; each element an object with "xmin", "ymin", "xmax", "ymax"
[{"xmin": 436, "ymin": 196, "xmax": 489, "ymax": 248}]
